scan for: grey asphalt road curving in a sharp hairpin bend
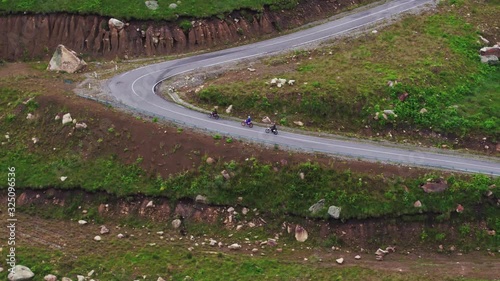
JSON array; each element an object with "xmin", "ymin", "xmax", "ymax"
[{"xmin": 107, "ymin": 0, "xmax": 500, "ymax": 176}]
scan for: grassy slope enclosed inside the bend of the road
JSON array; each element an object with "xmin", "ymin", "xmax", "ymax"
[{"xmin": 188, "ymin": 1, "xmax": 500, "ymax": 140}]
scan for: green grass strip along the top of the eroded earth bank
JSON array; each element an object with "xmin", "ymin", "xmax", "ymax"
[{"xmin": 0, "ymin": 0, "xmax": 297, "ymax": 20}]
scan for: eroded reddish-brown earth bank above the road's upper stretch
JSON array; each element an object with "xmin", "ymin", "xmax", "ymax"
[{"xmin": 0, "ymin": 0, "xmax": 371, "ymax": 60}]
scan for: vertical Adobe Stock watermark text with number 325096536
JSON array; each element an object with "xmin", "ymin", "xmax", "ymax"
[{"xmin": 6, "ymin": 167, "xmax": 17, "ymax": 272}]
